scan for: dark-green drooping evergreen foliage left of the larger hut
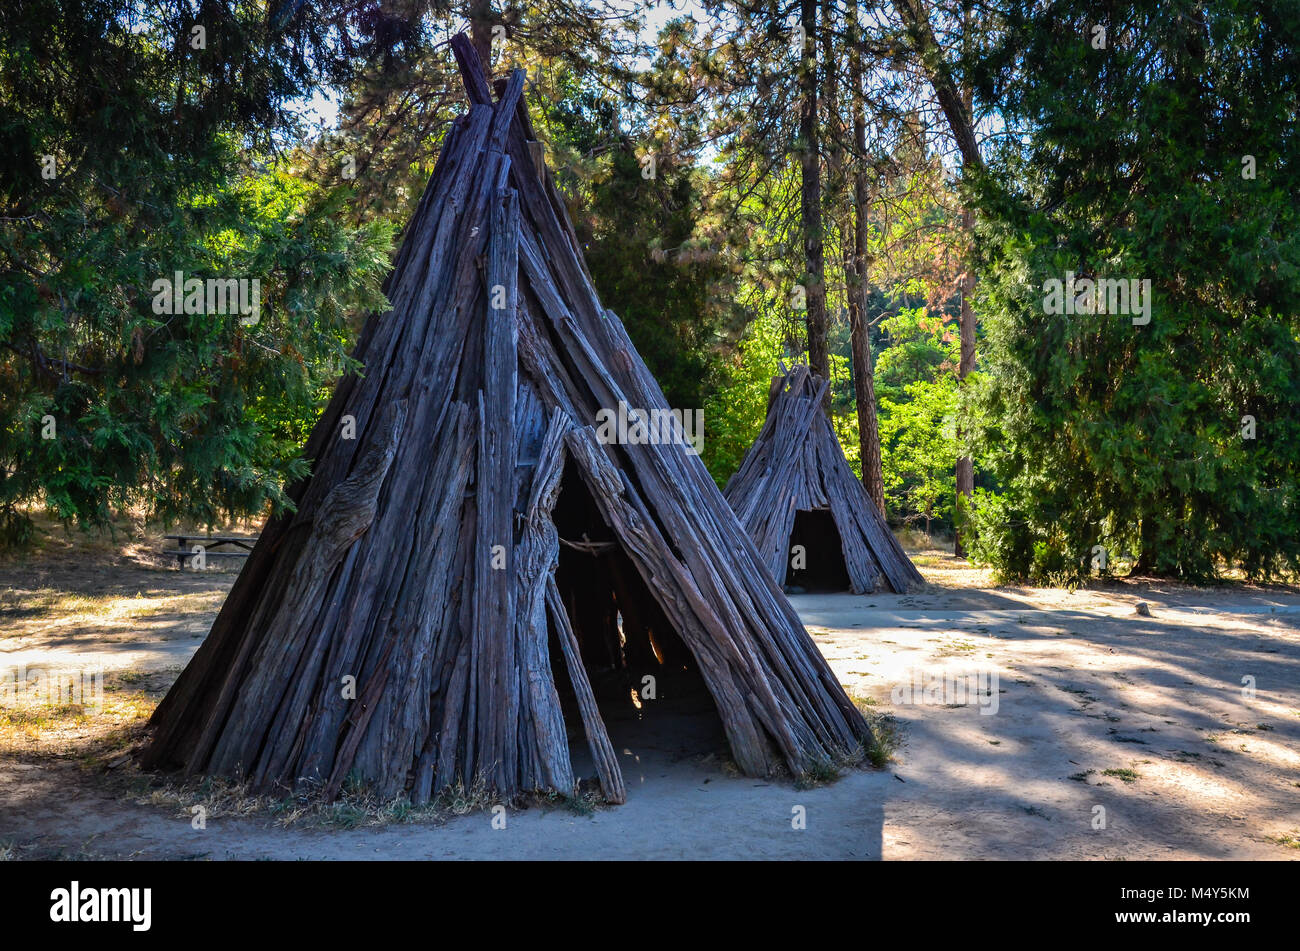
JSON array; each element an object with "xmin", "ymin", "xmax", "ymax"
[{"xmin": 0, "ymin": 0, "xmax": 391, "ymax": 542}]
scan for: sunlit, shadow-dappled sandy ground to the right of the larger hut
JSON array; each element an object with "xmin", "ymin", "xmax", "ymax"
[{"xmin": 792, "ymin": 590, "xmax": 1300, "ymax": 859}]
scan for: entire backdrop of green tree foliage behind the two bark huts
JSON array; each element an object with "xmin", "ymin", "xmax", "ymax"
[{"xmin": 0, "ymin": 0, "xmax": 1300, "ymax": 595}]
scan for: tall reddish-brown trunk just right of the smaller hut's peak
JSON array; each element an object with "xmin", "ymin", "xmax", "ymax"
[{"xmin": 845, "ymin": 0, "xmax": 885, "ymax": 514}]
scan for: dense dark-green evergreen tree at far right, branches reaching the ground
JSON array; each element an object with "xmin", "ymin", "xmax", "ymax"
[{"xmin": 971, "ymin": 0, "xmax": 1300, "ymax": 581}]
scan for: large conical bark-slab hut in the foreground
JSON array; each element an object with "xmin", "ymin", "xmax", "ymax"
[{"xmin": 142, "ymin": 36, "xmax": 870, "ymax": 803}]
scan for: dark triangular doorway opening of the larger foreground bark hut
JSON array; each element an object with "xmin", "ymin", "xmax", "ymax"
[{"xmin": 550, "ymin": 464, "xmax": 728, "ymax": 787}]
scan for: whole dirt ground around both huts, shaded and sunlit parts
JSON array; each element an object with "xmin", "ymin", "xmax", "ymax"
[{"xmin": 0, "ymin": 543, "xmax": 1300, "ymax": 860}]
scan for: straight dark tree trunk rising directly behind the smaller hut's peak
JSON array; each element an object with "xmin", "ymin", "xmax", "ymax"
[{"xmin": 800, "ymin": 0, "xmax": 831, "ymax": 400}]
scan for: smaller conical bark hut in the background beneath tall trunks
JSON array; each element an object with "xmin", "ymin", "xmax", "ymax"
[{"xmin": 723, "ymin": 364, "xmax": 923, "ymax": 594}]
